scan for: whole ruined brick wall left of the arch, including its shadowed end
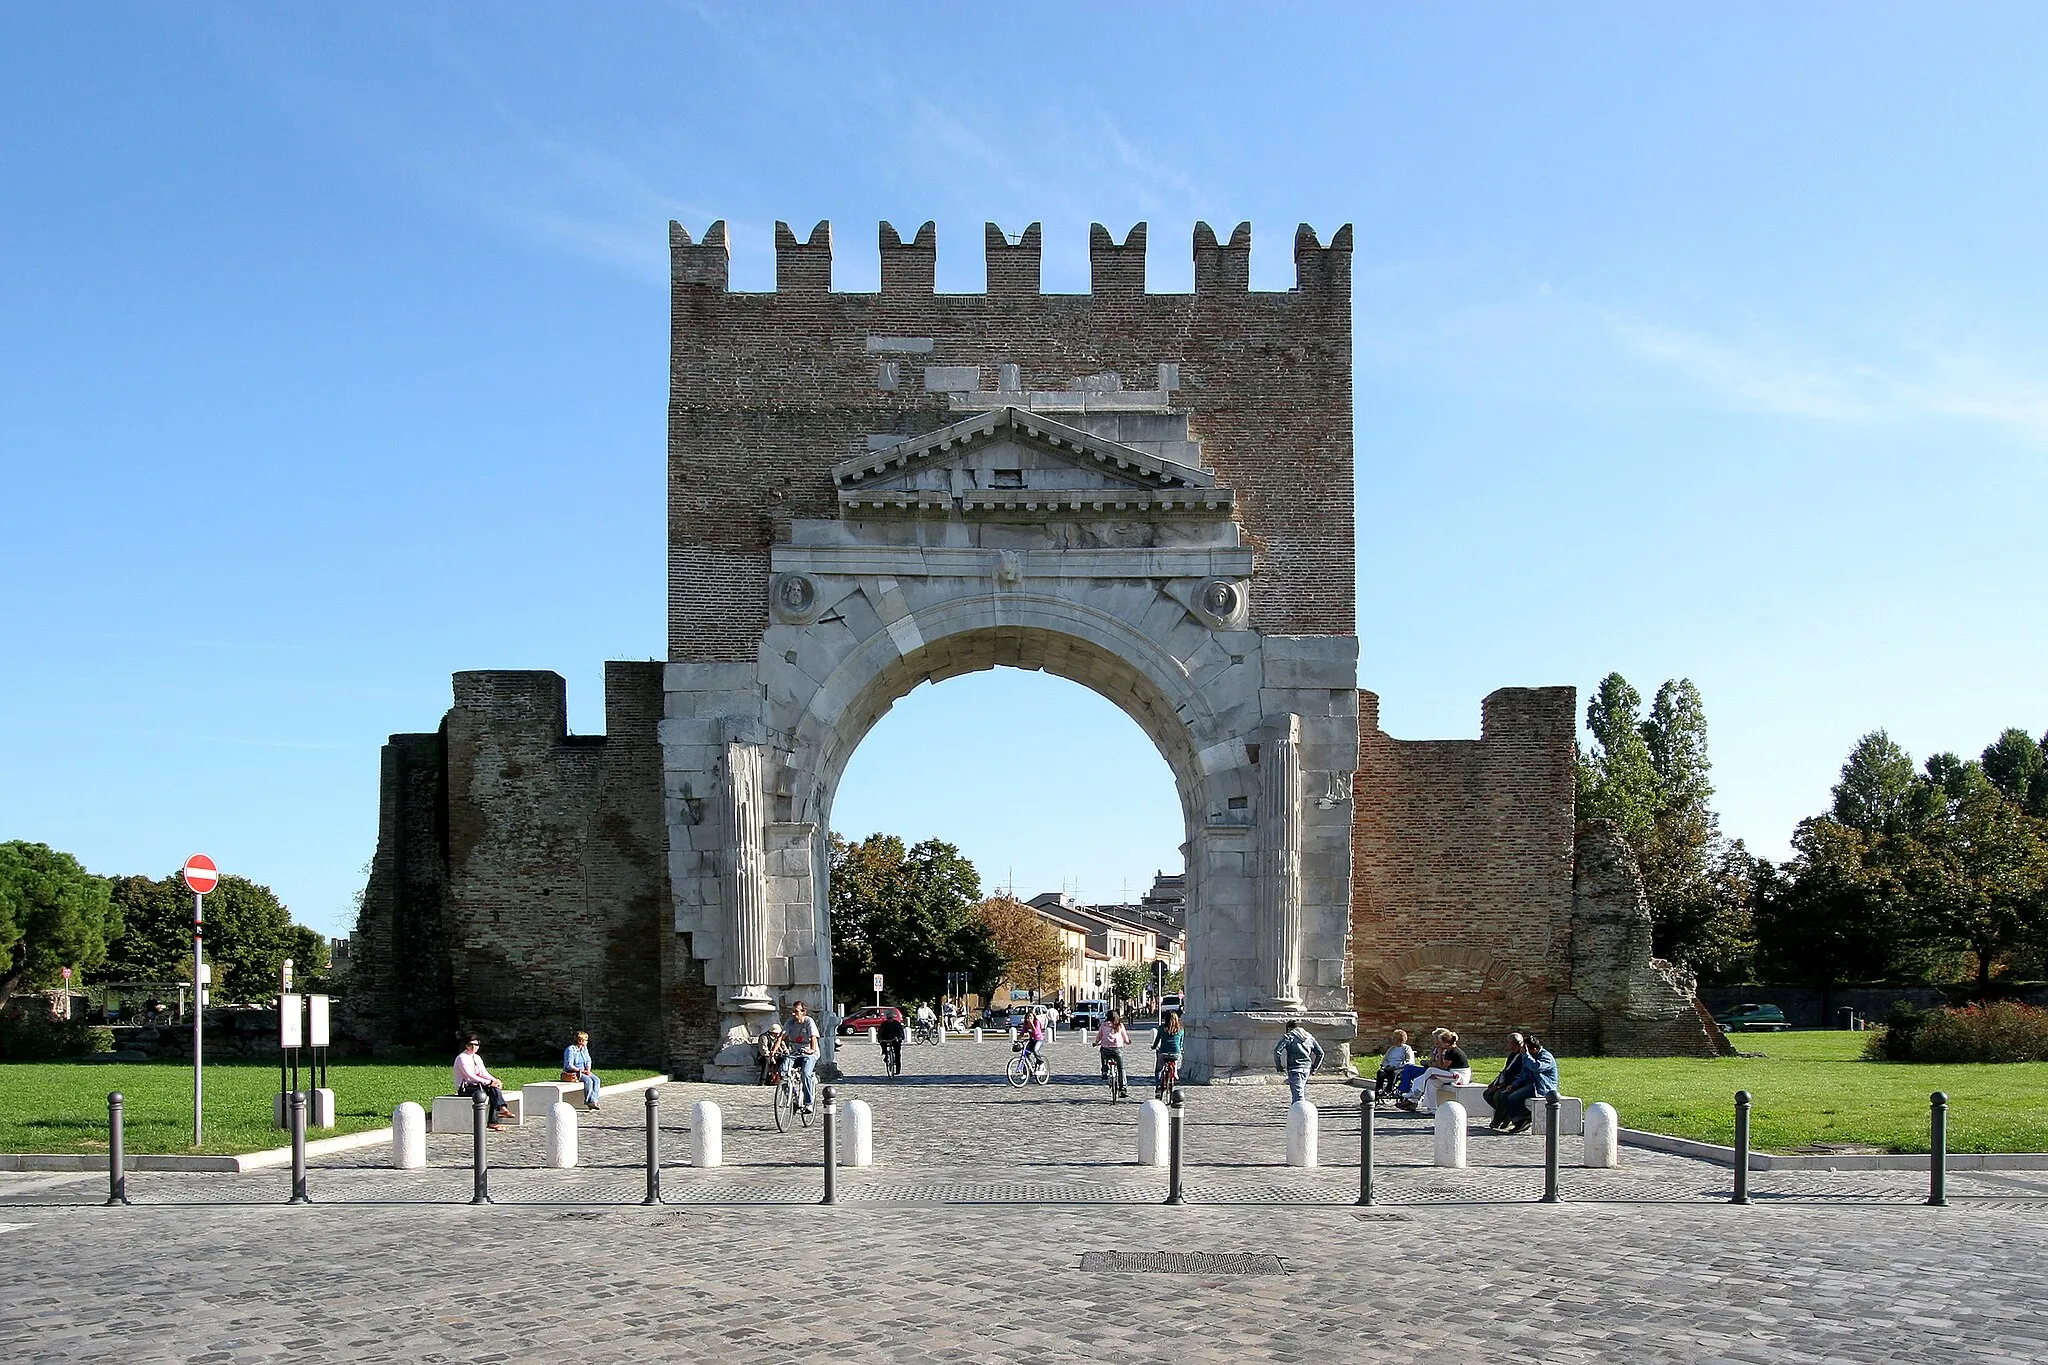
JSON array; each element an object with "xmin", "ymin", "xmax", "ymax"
[{"xmin": 348, "ymin": 663, "xmax": 690, "ymax": 1064}]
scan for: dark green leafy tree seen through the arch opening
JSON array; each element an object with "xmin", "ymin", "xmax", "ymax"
[{"xmin": 831, "ymin": 835, "xmax": 1001, "ymax": 999}]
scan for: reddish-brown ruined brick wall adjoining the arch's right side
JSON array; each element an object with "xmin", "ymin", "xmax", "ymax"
[{"xmin": 1352, "ymin": 688, "xmax": 1593, "ymax": 1052}]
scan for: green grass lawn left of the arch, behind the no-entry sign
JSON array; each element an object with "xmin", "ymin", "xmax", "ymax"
[{"xmin": 0, "ymin": 1060, "xmax": 653, "ymax": 1154}]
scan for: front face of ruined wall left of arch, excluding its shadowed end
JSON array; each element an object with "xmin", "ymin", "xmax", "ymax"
[{"xmin": 444, "ymin": 663, "xmax": 684, "ymax": 1066}]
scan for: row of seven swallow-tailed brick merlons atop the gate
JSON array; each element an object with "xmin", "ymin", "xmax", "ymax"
[{"xmin": 668, "ymin": 219, "xmax": 1352, "ymax": 299}]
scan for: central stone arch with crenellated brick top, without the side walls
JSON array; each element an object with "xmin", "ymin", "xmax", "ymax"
[{"xmin": 659, "ymin": 227, "xmax": 1358, "ymax": 1078}]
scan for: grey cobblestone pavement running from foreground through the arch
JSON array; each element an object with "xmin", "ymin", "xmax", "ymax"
[{"xmin": 0, "ymin": 1042, "xmax": 2048, "ymax": 1365}]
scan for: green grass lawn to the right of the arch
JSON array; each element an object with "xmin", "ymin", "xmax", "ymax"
[{"xmin": 1360, "ymin": 1031, "xmax": 2048, "ymax": 1152}]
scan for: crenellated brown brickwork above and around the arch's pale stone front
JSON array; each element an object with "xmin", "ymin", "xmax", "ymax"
[{"xmin": 668, "ymin": 223, "xmax": 1356, "ymax": 661}]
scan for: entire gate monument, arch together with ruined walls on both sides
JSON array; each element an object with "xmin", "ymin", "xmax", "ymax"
[{"xmin": 348, "ymin": 223, "xmax": 1716, "ymax": 1078}]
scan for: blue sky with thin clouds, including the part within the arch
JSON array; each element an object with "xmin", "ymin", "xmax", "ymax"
[{"xmin": 0, "ymin": 4, "xmax": 2048, "ymax": 933}]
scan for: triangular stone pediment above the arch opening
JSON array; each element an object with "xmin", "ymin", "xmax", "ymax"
[{"xmin": 831, "ymin": 407, "xmax": 1217, "ymax": 497}]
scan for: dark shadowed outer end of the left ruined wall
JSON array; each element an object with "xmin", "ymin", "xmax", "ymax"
[{"xmin": 336, "ymin": 733, "xmax": 455, "ymax": 1052}]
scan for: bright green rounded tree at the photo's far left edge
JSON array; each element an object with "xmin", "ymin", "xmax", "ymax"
[{"xmin": 0, "ymin": 839, "xmax": 121, "ymax": 1007}]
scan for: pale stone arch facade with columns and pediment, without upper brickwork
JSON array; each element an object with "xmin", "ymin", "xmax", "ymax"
[{"xmin": 662, "ymin": 389, "xmax": 1358, "ymax": 1081}]
